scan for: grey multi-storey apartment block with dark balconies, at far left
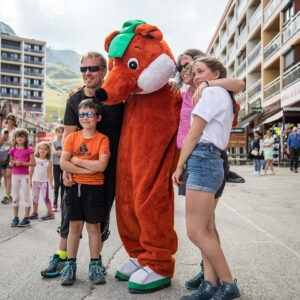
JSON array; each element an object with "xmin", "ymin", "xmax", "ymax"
[{"xmin": 0, "ymin": 33, "xmax": 46, "ymax": 121}]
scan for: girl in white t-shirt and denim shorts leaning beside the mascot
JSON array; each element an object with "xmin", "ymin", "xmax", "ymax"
[{"xmin": 173, "ymin": 57, "xmax": 240, "ymax": 300}]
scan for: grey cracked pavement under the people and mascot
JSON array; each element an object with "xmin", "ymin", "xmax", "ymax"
[{"xmin": 0, "ymin": 166, "xmax": 300, "ymax": 300}]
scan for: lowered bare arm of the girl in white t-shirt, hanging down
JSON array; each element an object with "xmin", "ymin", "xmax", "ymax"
[{"xmin": 172, "ymin": 115, "xmax": 206, "ymax": 185}]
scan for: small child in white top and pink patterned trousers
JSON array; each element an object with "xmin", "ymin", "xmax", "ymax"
[{"xmin": 29, "ymin": 142, "xmax": 54, "ymax": 220}]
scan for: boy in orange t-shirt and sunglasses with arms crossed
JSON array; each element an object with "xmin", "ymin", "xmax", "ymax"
[{"xmin": 60, "ymin": 99, "xmax": 110, "ymax": 285}]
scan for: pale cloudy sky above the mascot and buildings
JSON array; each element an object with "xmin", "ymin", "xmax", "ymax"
[{"xmin": 0, "ymin": 0, "xmax": 228, "ymax": 57}]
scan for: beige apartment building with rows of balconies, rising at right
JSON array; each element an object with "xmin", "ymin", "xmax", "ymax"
[{"xmin": 207, "ymin": 0, "xmax": 300, "ymax": 133}]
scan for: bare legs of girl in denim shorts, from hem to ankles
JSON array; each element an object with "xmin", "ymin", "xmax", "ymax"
[{"xmin": 186, "ymin": 189, "xmax": 232, "ymax": 284}]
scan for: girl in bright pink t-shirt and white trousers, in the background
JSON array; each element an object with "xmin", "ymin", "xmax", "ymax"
[{"xmin": 9, "ymin": 129, "xmax": 35, "ymax": 227}]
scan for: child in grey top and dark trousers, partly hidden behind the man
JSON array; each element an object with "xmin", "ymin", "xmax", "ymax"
[{"xmin": 51, "ymin": 125, "xmax": 65, "ymax": 212}]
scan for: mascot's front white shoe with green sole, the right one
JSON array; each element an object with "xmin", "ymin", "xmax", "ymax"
[{"xmin": 128, "ymin": 266, "xmax": 171, "ymax": 294}]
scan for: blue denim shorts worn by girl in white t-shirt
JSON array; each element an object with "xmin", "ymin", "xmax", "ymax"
[{"xmin": 186, "ymin": 143, "xmax": 224, "ymax": 194}]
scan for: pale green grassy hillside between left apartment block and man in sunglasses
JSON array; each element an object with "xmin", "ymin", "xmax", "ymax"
[{"xmin": 45, "ymin": 62, "xmax": 82, "ymax": 122}]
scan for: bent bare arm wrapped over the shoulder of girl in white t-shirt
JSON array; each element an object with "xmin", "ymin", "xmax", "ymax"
[{"xmin": 192, "ymin": 78, "xmax": 245, "ymax": 104}]
